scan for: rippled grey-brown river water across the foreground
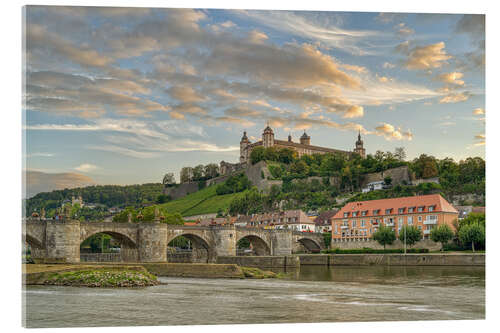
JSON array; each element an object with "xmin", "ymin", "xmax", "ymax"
[{"xmin": 23, "ymin": 266, "xmax": 485, "ymax": 327}]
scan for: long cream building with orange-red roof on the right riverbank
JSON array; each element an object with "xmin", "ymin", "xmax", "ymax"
[{"xmin": 331, "ymin": 194, "xmax": 458, "ymax": 242}]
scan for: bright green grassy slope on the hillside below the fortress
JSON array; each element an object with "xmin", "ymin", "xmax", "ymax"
[{"xmin": 161, "ymin": 186, "xmax": 238, "ymax": 216}]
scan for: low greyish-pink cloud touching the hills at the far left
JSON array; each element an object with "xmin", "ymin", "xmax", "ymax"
[{"xmin": 25, "ymin": 170, "xmax": 95, "ymax": 198}]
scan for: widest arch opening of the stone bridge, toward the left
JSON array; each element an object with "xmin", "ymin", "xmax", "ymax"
[{"xmin": 80, "ymin": 229, "xmax": 139, "ymax": 262}]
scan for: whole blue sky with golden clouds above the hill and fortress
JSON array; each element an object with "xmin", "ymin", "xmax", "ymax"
[{"xmin": 23, "ymin": 6, "xmax": 486, "ymax": 196}]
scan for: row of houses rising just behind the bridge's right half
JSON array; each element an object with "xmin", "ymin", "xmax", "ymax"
[{"xmin": 234, "ymin": 209, "xmax": 315, "ymax": 232}]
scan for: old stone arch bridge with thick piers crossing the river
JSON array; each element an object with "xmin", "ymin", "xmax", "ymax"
[{"xmin": 23, "ymin": 218, "xmax": 325, "ymax": 263}]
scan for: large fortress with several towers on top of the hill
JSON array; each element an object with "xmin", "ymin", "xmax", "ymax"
[{"xmin": 236, "ymin": 125, "xmax": 366, "ymax": 163}]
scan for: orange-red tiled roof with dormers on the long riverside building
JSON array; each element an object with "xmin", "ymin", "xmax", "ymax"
[{"xmin": 333, "ymin": 194, "xmax": 458, "ymax": 219}]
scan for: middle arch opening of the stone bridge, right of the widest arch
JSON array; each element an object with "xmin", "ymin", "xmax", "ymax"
[{"xmin": 167, "ymin": 231, "xmax": 215, "ymax": 263}]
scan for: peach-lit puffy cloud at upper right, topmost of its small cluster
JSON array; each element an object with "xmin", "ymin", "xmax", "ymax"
[{"xmin": 400, "ymin": 42, "xmax": 452, "ymax": 70}]
